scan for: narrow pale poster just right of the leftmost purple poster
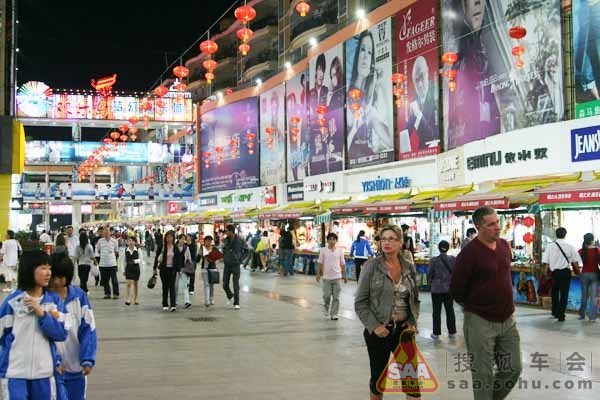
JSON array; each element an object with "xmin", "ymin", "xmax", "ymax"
[{"xmin": 260, "ymin": 85, "xmax": 285, "ymax": 186}]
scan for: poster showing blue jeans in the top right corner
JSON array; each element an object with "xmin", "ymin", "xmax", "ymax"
[{"xmin": 573, "ymin": 0, "xmax": 600, "ymax": 118}]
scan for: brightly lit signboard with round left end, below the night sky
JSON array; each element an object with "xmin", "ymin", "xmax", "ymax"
[{"xmin": 17, "ymin": 82, "xmax": 193, "ymax": 122}]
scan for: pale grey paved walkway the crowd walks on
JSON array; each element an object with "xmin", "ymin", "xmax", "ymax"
[{"xmin": 4, "ymin": 262, "xmax": 600, "ymax": 400}]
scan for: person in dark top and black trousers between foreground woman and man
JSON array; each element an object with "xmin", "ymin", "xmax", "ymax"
[{"xmin": 427, "ymin": 240, "xmax": 456, "ymax": 340}]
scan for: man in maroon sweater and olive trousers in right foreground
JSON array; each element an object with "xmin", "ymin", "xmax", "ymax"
[{"xmin": 450, "ymin": 207, "xmax": 522, "ymax": 400}]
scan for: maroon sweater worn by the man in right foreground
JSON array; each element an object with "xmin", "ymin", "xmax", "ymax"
[{"xmin": 450, "ymin": 239, "xmax": 515, "ymax": 322}]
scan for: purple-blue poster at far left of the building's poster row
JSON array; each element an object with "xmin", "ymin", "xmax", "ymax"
[{"xmin": 200, "ymin": 97, "xmax": 259, "ymax": 192}]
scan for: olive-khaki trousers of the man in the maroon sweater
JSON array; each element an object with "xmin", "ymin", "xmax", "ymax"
[{"xmin": 464, "ymin": 311, "xmax": 523, "ymax": 400}]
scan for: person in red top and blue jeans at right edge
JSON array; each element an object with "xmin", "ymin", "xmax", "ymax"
[{"xmin": 579, "ymin": 233, "xmax": 600, "ymax": 322}]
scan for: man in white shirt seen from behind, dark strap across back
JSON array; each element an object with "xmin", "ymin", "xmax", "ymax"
[{"xmin": 542, "ymin": 228, "xmax": 583, "ymax": 322}]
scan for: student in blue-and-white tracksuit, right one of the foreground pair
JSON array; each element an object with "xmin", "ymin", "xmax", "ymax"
[{"xmin": 51, "ymin": 255, "xmax": 97, "ymax": 400}]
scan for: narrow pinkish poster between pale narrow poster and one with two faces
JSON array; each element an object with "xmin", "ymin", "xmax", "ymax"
[{"xmin": 285, "ymin": 71, "xmax": 310, "ymax": 182}]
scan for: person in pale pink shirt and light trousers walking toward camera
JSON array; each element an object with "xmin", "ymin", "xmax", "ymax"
[{"xmin": 317, "ymin": 232, "xmax": 348, "ymax": 321}]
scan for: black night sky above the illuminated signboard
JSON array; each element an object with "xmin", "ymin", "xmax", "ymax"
[{"xmin": 17, "ymin": 0, "xmax": 235, "ymax": 140}]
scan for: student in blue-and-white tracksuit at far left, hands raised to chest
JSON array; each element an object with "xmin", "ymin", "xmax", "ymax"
[{"xmin": 0, "ymin": 250, "xmax": 68, "ymax": 400}]
